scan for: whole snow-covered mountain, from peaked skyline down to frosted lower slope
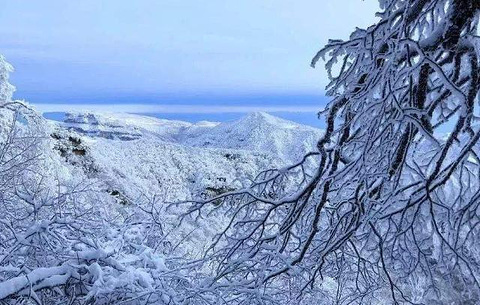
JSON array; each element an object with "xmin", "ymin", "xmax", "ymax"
[{"xmin": 51, "ymin": 112, "xmax": 322, "ymax": 201}]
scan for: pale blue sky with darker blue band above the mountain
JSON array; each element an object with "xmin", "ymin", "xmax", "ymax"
[{"xmin": 0, "ymin": 0, "xmax": 378, "ymax": 117}]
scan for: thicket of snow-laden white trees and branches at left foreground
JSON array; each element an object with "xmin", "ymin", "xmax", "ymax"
[{"xmin": 0, "ymin": 57, "xmax": 212, "ymax": 304}]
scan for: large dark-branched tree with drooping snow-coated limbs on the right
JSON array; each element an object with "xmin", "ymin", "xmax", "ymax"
[{"xmin": 189, "ymin": 0, "xmax": 480, "ymax": 304}]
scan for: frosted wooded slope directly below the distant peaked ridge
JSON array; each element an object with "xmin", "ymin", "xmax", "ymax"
[{"xmin": 87, "ymin": 138, "xmax": 275, "ymax": 202}]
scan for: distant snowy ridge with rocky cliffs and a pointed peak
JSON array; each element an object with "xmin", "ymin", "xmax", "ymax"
[{"xmin": 62, "ymin": 112, "xmax": 321, "ymax": 163}]
